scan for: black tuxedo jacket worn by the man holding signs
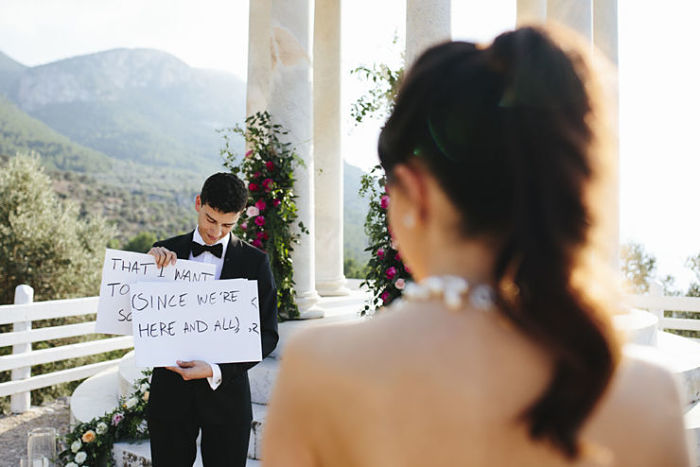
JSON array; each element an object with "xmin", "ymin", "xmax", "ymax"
[{"xmin": 147, "ymin": 232, "xmax": 279, "ymax": 426}]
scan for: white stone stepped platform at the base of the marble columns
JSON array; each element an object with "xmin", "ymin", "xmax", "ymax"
[{"xmin": 71, "ymin": 281, "xmax": 700, "ymax": 467}]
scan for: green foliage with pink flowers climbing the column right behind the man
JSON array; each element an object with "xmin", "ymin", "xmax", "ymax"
[{"xmin": 221, "ymin": 112, "xmax": 308, "ymax": 319}]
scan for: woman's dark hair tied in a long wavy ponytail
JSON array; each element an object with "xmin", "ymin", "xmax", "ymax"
[{"xmin": 379, "ymin": 28, "xmax": 617, "ymax": 458}]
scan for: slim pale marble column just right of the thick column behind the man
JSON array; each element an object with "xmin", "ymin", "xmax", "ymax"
[{"xmin": 313, "ymin": 0, "xmax": 350, "ymax": 296}]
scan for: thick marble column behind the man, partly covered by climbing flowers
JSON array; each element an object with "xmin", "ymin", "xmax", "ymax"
[{"xmin": 247, "ymin": 0, "xmax": 323, "ymax": 319}]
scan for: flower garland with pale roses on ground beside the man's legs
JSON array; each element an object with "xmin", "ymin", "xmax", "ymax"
[{"xmin": 58, "ymin": 370, "xmax": 151, "ymax": 467}]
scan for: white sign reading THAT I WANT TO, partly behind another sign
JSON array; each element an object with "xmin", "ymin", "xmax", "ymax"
[{"xmin": 95, "ymin": 248, "xmax": 216, "ymax": 335}]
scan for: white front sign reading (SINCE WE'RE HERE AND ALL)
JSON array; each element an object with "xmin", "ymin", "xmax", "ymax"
[{"xmin": 131, "ymin": 279, "xmax": 262, "ymax": 367}]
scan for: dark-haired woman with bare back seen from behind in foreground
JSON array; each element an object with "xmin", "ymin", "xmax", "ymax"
[{"xmin": 263, "ymin": 28, "xmax": 690, "ymax": 467}]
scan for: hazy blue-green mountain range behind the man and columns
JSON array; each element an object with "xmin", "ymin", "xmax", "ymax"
[{"xmin": 0, "ymin": 49, "xmax": 367, "ymax": 266}]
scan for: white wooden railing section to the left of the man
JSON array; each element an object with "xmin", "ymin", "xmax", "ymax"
[{"xmin": 0, "ymin": 285, "xmax": 133, "ymax": 413}]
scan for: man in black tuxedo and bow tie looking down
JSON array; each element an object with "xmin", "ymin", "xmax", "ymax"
[{"xmin": 146, "ymin": 173, "xmax": 279, "ymax": 467}]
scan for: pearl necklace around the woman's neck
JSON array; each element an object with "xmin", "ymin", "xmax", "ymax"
[{"xmin": 396, "ymin": 276, "xmax": 495, "ymax": 311}]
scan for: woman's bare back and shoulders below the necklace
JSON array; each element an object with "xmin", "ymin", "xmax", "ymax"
[{"xmin": 264, "ymin": 302, "xmax": 689, "ymax": 467}]
